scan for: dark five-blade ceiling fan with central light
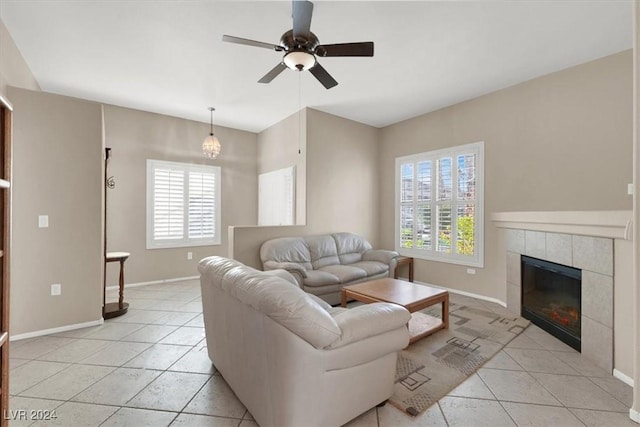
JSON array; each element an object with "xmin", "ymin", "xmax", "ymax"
[{"xmin": 222, "ymin": 0, "xmax": 373, "ymax": 89}]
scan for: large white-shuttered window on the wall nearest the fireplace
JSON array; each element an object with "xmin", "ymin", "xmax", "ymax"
[{"xmin": 396, "ymin": 142, "xmax": 484, "ymax": 267}]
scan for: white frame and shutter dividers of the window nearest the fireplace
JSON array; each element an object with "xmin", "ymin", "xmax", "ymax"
[{"xmin": 394, "ymin": 141, "xmax": 485, "ymax": 268}]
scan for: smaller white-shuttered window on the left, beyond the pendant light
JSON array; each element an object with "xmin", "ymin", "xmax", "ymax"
[{"xmin": 147, "ymin": 160, "xmax": 220, "ymax": 249}]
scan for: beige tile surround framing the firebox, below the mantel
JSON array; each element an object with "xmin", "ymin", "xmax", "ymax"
[{"xmin": 506, "ymin": 229, "xmax": 613, "ymax": 372}]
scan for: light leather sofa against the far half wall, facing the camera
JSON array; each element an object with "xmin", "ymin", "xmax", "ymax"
[{"xmin": 260, "ymin": 233, "xmax": 398, "ymax": 305}]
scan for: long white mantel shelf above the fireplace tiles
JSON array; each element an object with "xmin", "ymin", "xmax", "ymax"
[{"xmin": 491, "ymin": 210, "xmax": 633, "ymax": 240}]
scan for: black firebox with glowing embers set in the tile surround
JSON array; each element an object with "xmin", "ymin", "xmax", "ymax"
[{"xmin": 521, "ymin": 255, "xmax": 582, "ymax": 351}]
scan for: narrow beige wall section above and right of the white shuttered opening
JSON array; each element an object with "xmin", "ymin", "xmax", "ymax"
[{"xmin": 258, "ymin": 109, "xmax": 307, "ymax": 224}]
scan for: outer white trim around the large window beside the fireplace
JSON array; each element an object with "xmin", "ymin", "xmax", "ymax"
[{"xmin": 394, "ymin": 141, "xmax": 485, "ymax": 268}]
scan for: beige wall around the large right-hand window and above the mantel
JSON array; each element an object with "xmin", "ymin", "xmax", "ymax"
[{"xmin": 379, "ymin": 51, "xmax": 633, "ymax": 301}]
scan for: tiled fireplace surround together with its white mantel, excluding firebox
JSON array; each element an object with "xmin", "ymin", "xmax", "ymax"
[{"xmin": 492, "ymin": 211, "xmax": 631, "ymax": 372}]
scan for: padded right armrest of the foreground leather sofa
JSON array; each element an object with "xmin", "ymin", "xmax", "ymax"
[{"xmin": 326, "ymin": 302, "xmax": 411, "ymax": 349}]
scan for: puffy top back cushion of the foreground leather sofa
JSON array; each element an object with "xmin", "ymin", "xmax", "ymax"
[{"xmin": 198, "ymin": 256, "xmax": 342, "ymax": 348}]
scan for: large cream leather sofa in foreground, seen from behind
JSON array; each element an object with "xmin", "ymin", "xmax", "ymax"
[{"xmin": 198, "ymin": 256, "xmax": 411, "ymax": 427}]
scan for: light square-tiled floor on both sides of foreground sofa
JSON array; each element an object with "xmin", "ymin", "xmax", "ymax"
[{"xmin": 10, "ymin": 280, "xmax": 638, "ymax": 427}]
